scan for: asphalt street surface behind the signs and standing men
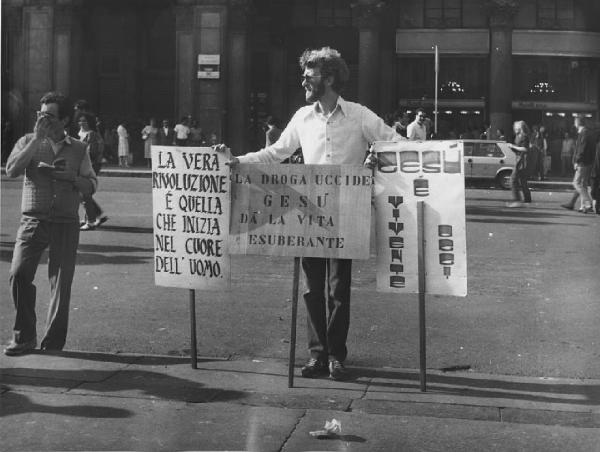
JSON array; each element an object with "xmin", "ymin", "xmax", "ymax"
[{"xmin": 0, "ymin": 176, "xmax": 600, "ymax": 379}]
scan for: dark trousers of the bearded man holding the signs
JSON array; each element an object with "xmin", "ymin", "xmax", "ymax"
[{"xmin": 302, "ymin": 257, "xmax": 352, "ymax": 361}]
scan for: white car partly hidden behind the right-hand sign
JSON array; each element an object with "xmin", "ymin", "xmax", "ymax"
[{"xmin": 461, "ymin": 140, "xmax": 516, "ymax": 190}]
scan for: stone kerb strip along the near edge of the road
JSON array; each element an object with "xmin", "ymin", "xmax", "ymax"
[{"xmin": 0, "ymin": 351, "xmax": 600, "ymax": 428}]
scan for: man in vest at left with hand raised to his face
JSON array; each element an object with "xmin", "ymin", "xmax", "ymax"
[{"xmin": 4, "ymin": 92, "xmax": 97, "ymax": 356}]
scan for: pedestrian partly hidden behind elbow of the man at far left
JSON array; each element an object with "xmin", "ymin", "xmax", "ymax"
[{"xmin": 78, "ymin": 112, "xmax": 108, "ymax": 231}]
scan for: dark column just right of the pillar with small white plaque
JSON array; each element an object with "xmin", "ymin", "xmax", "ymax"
[{"xmin": 227, "ymin": 0, "xmax": 254, "ymax": 155}]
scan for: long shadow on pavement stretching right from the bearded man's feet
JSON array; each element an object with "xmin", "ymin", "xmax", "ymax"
[{"xmin": 352, "ymin": 369, "xmax": 600, "ymax": 406}]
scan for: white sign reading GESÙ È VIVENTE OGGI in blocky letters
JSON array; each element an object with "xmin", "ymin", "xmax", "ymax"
[{"xmin": 374, "ymin": 141, "xmax": 467, "ymax": 296}]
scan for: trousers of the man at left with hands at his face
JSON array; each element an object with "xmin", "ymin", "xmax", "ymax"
[{"xmin": 9, "ymin": 218, "xmax": 79, "ymax": 350}]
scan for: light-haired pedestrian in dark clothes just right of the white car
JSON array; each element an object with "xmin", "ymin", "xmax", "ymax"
[{"xmin": 508, "ymin": 121, "xmax": 536, "ymax": 207}]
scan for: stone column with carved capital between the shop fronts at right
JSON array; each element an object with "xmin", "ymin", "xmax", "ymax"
[{"xmin": 486, "ymin": 0, "xmax": 518, "ymax": 137}]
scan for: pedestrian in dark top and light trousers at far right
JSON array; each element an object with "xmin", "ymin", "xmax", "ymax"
[{"xmin": 561, "ymin": 116, "xmax": 596, "ymax": 213}]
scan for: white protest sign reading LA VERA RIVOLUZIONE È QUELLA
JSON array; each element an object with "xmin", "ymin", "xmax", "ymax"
[{"xmin": 152, "ymin": 146, "xmax": 231, "ymax": 289}]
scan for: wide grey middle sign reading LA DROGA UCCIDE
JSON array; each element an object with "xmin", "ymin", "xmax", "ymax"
[{"xmin": 230, "ymin": 164, "xmax": 373, "ymax": 259}]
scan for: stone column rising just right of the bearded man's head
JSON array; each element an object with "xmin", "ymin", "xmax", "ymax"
[{"xmin": 354, "ymin": 0, "xmax": 385, "ymax": 111}]
